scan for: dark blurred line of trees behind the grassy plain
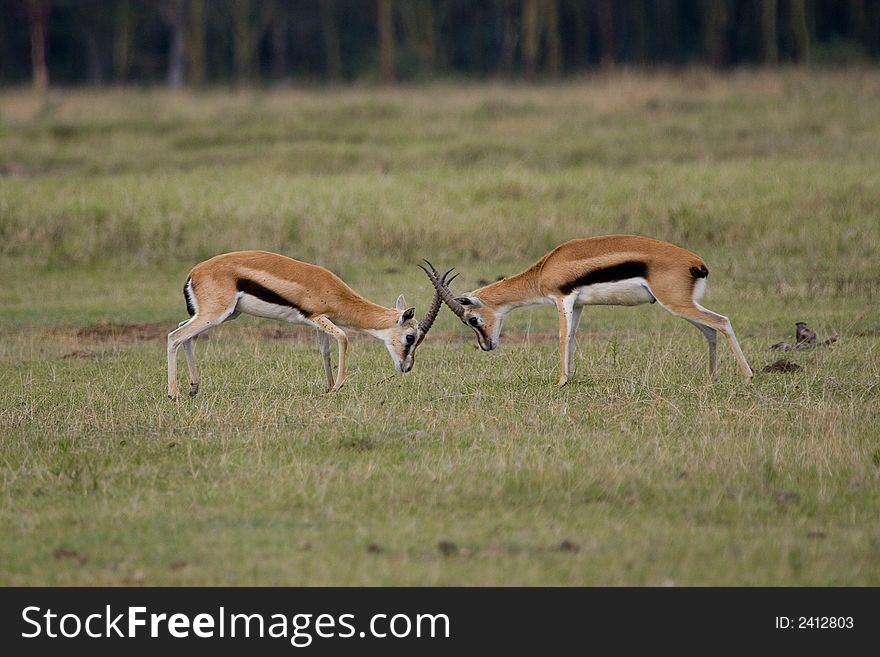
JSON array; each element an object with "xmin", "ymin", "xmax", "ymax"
[{"xmin": 0, "ymin": 0, "xmax": 880, "ymax": 90}]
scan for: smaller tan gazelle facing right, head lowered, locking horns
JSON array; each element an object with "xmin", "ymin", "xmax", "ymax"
[{"xmin": 168, "ymin": 251, "xmax": 447, "ymax": 399}]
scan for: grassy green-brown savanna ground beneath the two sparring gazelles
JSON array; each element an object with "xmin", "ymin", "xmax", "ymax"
[{"xmin": 0, "ymin": 71, "xmax": 880, "ymax": 585}]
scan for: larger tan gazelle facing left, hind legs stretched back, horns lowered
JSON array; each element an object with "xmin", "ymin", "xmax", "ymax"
[{"xmin": 422, "ymin": 235, "xmax": 752, "ymax": 386}]
